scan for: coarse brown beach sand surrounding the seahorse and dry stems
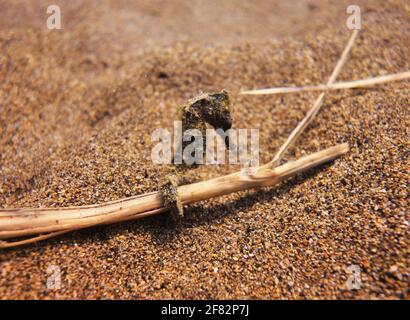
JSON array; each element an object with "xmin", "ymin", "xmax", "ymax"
[{"xmin": 0, "ymin": 0, "xmax": 410, "ymax": 299}]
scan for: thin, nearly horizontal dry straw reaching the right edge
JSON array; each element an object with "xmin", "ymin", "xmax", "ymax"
[{"xmin": 240, "ymin": 71, "xmax": 410, "ymax": 95}]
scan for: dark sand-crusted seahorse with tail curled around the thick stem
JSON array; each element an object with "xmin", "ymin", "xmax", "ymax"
[{"xmin": 160, "ymin": 90, "xmax": 232, "ymax": 220}]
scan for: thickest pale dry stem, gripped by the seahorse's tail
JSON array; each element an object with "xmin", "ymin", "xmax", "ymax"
[{"xmin": 0, "ymin": 144, "xmax": 349, "ymax": 248}]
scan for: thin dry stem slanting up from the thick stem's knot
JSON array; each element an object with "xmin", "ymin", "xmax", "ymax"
[{"xmin": 266, "ymin": 30, "xmax": 359, "ymax": 168}]
